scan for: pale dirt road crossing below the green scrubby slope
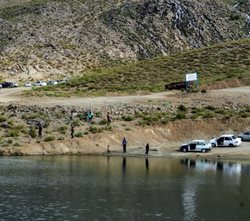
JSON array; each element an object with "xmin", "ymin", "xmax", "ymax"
[{"xmin": 0, "ymin": 86, "xmax": 250, "ymax": 108}]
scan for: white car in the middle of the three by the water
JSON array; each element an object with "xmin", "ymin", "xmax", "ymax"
[{"xmin": 210, "ymin": 134, "xmax": 242, "ymax": 147}]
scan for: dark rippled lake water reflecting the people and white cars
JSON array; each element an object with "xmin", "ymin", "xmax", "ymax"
[{"xmin": 0, "ymin": 156, "xmax": 250, "ymax": 221}]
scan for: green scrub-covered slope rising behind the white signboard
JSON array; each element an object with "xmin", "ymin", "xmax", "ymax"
[{"xmin": 28, "ymin": 39, "xmax": 250, "ymax": 96}]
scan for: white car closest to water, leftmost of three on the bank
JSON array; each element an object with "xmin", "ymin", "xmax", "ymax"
[{"xmin": 180, "ymin": 140, "xmax": 212, "ymax": 153}]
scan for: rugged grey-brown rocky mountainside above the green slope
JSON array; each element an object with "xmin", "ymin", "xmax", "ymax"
[{"xmin": 0, "ymin": 0, "xmax": 249, "ymax": 80}]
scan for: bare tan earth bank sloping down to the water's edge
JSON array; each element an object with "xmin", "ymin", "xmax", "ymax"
[{"xmin": 0, "ymin": 118, "xmax": 250, "ymax": 159}]
